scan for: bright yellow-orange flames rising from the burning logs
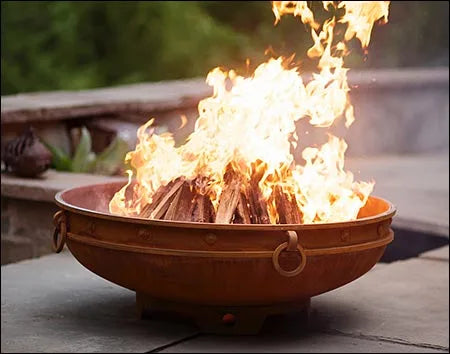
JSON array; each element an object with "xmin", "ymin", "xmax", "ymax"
[{"xmin": 110, "ymin": 1, "xmax": 389, "ymax": 223}]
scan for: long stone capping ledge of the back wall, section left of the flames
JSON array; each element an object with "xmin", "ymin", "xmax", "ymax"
[{"xmin": 1, "ymin": 79, "xmax": 211, "ymax": 124}]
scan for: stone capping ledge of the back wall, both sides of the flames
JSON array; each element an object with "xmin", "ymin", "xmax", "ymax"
[{"xmin": 1, "ymin": 67, "xmax": 449, "ymax": 124}]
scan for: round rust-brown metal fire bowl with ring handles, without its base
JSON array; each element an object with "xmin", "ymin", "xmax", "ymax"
[{"xmin": 53, "ymin": 182, "xmax": 395, "ymax": 334}]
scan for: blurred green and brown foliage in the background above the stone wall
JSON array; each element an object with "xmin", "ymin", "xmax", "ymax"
[{"xmin": 1, "ymin": 1, "xmax": 449, "ymax": 95}]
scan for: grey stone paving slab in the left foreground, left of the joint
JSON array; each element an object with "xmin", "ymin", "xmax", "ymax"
[{"xmin": 1, "ymin": 252, "xmax": 197, "ymax": 353}]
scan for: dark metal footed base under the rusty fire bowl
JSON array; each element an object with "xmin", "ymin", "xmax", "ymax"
[{"xmin": 136, "ymin": 292, "xmax": 311, "ymax": 335}]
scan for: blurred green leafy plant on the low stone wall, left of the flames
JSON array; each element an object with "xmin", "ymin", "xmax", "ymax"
[{"xmin": 41, "ymin": 127, "xmax": 129, "ymax": 175}]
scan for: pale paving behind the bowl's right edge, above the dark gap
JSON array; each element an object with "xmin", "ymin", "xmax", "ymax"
[{"xmin": 346, "ymin": 153, "xmax": 449, "ymax": 237}]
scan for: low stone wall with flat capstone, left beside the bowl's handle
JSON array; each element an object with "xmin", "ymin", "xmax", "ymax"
[{"xmin": 1, "ymin": 170, "xmax": 124, "ymax": 264}]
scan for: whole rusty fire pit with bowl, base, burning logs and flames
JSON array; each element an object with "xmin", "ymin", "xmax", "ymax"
[{"xmin": 50, "ymin": 1, "xmax": 395, "ymax": 334}]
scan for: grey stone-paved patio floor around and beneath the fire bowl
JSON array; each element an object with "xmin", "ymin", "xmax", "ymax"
[{"xmin": 1, "ymin": 153, "xmax": 449, "ymax": 353}]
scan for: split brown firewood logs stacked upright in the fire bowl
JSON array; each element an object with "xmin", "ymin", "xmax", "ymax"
[{"xmin": 139, "ymin": 169, "xmax": 302, "ymax": 224}]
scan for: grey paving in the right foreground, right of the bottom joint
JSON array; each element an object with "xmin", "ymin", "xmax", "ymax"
[{"xmin": 161, "ymin": 259, "xmax": 449, "ymax": 353}]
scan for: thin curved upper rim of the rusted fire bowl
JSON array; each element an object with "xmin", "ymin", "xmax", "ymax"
[{"xmin": 55, "ymin": 181, "xmax": 397, "ymax": 231}]
